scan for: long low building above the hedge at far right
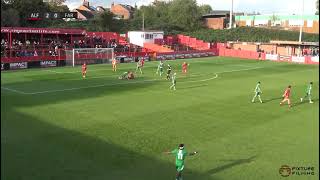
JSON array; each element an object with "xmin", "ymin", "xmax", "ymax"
[{"xmin": 235, "ymin": 14, "xmax": 319, "ymax": 34}]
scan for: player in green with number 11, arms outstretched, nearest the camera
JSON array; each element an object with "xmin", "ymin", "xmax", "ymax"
[{"xmin": 165, "ymin": 144, "xmax": 198, "ymax": 180}]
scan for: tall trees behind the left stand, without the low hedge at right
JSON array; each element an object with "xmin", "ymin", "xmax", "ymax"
[{"xmin": 1, "ymin": 0, "xmax": 212, "ymax": 33}]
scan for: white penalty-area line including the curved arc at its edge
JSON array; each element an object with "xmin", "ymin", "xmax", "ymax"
[{"xmin": 1, "ymin": 67, "xmax": 264, "ymax": 95}]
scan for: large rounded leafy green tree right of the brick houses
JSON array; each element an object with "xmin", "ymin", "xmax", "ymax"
[{"xmin": 130, "ymin": 0, "xmax": 211, "ymax": 33}]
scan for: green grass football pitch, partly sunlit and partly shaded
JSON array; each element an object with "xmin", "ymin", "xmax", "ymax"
[{"xmin": 1, "ymin": 57, "xmax": 319, "ymax": 180}]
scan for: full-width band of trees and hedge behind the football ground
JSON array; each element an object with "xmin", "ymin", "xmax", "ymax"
[{"xmin": 1, "ymin": 0, "xmax": 319, "ymax": 42}]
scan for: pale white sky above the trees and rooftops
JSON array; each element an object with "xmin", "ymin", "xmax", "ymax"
[{"xmin": 66, "ymin": 0, "xmax": 316, "ymax": 14}]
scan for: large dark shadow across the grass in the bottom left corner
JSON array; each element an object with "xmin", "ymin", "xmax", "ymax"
[{"xmin": 1, "ymin": 106, "xmax": 219, "ymax": 180}]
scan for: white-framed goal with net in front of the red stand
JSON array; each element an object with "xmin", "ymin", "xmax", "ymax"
[{"xmin": 66, "ymin": 48, "xmax": 114, "ymax": 66}]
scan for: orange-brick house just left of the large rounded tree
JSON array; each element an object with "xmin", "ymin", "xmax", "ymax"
[{"xmin": 110, "ymin": 3, "xmax": 134, "ymax": 19}]
